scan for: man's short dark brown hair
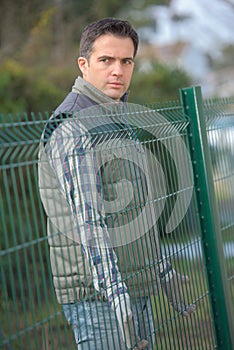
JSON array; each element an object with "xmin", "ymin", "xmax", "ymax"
[{"xmin": 80, "ymin": 17, "xmax": 139, "ymax": 59}]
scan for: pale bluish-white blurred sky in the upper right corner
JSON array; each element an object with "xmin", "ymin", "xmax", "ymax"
[{"xmin": 147, "ymin": 0, "xmax": 234, "ymax": 55}]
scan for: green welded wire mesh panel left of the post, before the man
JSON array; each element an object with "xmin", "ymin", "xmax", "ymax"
[{"xmin": 0, "ymin": 104, "xmax": 218, "ymax": 350}]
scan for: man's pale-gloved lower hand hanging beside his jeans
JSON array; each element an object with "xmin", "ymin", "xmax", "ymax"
[{"xmin": 113, "ymin": 294, "xmax": 149, "ymax": 350}]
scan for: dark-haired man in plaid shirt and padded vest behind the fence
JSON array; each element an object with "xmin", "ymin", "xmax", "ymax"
[{"xmin": 39, "ymin": 18, "xmax": 195, "ymax": 350}]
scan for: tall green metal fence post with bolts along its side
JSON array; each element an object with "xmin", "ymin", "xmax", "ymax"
[{"xmin": 180, "ymin": 86, "xmax": 234, "ymax": 350}]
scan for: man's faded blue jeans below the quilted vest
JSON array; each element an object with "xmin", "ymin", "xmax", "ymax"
[{"xmin": 62, "ymin": 298, "xmax": 154, "ymax": 350}]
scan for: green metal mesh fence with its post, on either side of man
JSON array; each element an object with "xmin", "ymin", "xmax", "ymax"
[{"xmin": 0, "ymin": 87, "xmax": 234, "ymax": 350}]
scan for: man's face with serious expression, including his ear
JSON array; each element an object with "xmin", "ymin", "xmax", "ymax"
[{"xmin": 78, "ymin": 34, "xmax": 134, "ymax": 101}]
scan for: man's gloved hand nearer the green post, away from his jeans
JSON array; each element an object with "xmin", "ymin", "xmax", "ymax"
[{"xmin": 159, "ymin": 263, "xmax": 196, "ymax": 317}]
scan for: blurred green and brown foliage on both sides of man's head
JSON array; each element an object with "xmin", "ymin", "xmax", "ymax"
[{"xmin": 0, "ymin": 0, "xmax": 190, "ymax": 113}]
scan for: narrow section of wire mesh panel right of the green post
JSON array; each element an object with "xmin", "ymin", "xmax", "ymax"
[{"xmin": 204, "ymin": 99, "xmax": 234, "ymax": 302}]
